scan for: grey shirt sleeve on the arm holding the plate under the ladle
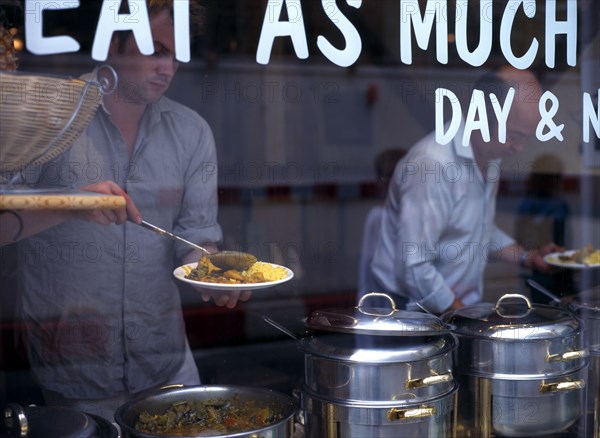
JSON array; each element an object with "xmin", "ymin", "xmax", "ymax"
[{"xmin": 174, "ymin": 116, "xmax": 223, "ymax": 259}]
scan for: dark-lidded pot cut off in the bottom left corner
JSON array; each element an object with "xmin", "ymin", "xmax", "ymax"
[{"xmin": 0, "ymin": 403, "xmax": 118, "ymax": 438}]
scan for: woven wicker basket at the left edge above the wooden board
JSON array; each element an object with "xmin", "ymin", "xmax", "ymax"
[{"xmin": 0, "ymin": 68, "xmax": 113, "ymax": 173}]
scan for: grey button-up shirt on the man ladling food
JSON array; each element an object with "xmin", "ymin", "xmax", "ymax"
[{"xmin": 20, "ymin": 97, "xmax": 222, "ymax": 398}]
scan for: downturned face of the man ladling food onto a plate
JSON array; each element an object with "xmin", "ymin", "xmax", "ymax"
[{"xmin": 109, "ymin": 11, "xmax": 179, "ymax": 105}]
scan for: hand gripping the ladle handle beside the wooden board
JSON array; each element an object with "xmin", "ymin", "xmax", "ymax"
[{"xmin": 73, "ymin": 181, "xmax": 142, "ymax": 225}]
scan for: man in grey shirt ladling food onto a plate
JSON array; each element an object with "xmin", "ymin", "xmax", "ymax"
[{"xmin": 10, "ymin": 0, "xmax": 247, "ymax": 420}]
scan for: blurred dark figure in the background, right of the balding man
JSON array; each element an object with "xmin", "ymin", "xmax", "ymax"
[{"xmin": 515, "ymin": 154, "xmax": 575, "ymax": 303}]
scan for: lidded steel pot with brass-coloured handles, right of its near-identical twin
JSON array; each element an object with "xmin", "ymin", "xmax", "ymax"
[{"xmin": 443, "ymin": 294, "xmax": 588, "ymax": 437}]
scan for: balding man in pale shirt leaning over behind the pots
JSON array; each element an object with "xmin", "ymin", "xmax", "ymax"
[{"xmin": 371, "ymin": 66, "xmax": 556, "ymax": 313}]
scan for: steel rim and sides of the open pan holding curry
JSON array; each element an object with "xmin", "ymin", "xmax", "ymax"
[{"xmin": 115, "ymin": 385, "xmax": 296, "ymax": 438}]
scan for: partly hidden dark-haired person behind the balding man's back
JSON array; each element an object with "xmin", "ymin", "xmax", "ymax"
[{"xmin": 358, "ymin": 149, "xmax": 406, "ymax": 297}]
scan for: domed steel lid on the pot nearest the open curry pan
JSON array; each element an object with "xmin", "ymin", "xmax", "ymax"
[{"xmin": 306, "ymin": 292, "xmax": 449, "ymax": 336}]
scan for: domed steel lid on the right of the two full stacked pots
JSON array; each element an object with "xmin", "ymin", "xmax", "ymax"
[{"xmin": 443, "ymin": 294, "xmax": 582, "ymax": 341}]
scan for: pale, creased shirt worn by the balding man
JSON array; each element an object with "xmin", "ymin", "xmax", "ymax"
[{"xmin": 371, "ymin": 125, "xmax": 514, "ymax": 313}]
